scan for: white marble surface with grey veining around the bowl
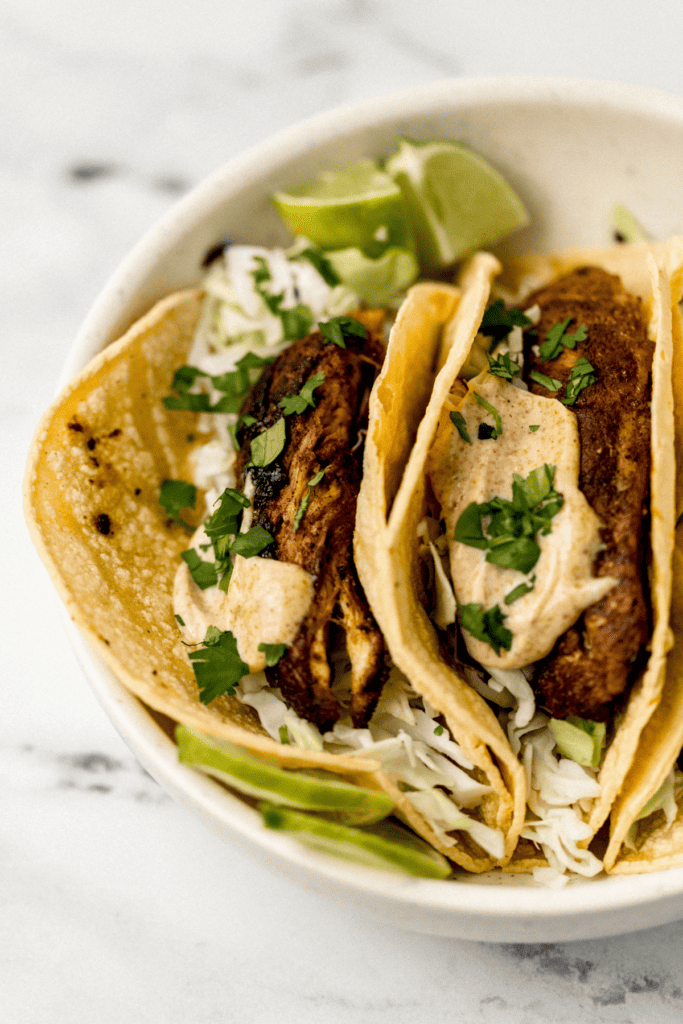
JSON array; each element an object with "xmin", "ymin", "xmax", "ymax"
[{"xmin": 9, "ymin": 0, "xmax": 683, "ymax": 1024}]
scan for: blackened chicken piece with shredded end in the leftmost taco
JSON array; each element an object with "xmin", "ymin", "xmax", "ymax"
[{"xmin": 236, "ymin": 313, "xmax": 386, "ymax": 731}]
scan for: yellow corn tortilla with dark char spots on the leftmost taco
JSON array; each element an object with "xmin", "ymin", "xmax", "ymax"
[{"xmin": 25, "ymin": 288, "xmax": 505, "ymax": 870}]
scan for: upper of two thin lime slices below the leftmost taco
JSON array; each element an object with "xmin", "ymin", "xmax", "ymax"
[{"xmin": 175, "ymin": 725, "xmax": 394, "ymax": 824}]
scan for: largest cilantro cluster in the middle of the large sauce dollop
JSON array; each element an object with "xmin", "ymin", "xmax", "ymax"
[{"xmin": 455, "ymin": 463, "xmax": 564, "ymax": 573}]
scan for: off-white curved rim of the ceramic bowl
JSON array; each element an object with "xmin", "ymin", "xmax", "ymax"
[{"xmin": 57, "ymin": 76, "xmax": 683, "ymax": 941}]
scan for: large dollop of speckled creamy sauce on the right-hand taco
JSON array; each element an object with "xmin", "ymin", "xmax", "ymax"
[{"xmin": 428, "ymin": 373, "xmax": 617, "ymax": 669}]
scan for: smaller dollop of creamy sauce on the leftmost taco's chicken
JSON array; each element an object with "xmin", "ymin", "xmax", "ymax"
[{"xmin": 173, "ymin": 526, "xmax": 314, "ymax": 672}]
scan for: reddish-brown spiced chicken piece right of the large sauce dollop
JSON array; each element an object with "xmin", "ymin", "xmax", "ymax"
[{"xmin": 524, "ymin": 267, "xmax": 653, "ymax": 719}]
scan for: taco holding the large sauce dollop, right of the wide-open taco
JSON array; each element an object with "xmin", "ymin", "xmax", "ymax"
[{"xmin": 356, "ymin": 239, "xmax": 683, "ymax": 878}]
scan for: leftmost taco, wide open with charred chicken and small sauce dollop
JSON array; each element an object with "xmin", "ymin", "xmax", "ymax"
[{"xmin": 26, "ymin": 247, "xmax": 522, "ymax": 871}]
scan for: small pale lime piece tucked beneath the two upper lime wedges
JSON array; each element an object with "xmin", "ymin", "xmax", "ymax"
[{"xmin": 326, "ymin": 246, "xmax": 420, "ymax": 306}]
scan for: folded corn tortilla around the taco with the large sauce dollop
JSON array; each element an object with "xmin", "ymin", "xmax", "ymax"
[{"xmin": 355, "ymin": 239, "xmax": 683, "ymax": 871}]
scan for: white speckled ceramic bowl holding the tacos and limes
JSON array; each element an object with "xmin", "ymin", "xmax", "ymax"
[{"xmin": 58, "ymin": 78, "xmax": 683, "ymax": 942}]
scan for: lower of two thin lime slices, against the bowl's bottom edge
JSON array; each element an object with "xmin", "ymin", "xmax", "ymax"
[{"xmin": 260, "ymin": 804, "xmax": 451, "ymax": 879}]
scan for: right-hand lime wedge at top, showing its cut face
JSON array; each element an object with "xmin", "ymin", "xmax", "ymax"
[{"xmin": 386, "ymin": 141, "xmax": 528, "ymax": 272}]
